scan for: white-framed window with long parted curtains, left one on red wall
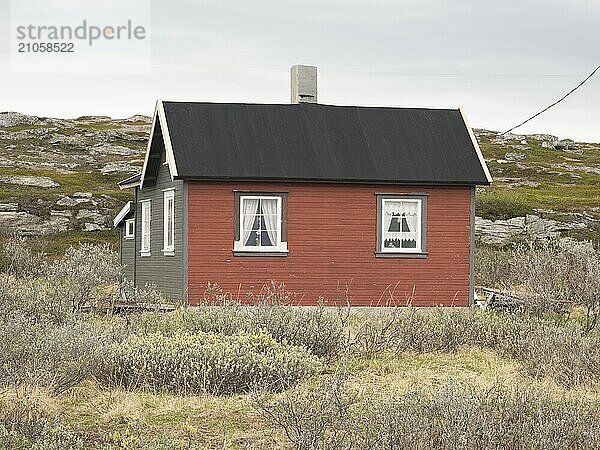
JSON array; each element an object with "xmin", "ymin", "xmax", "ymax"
[{"xmin": 233, "ymin": 192, "xmax": 287, "ymax": 256}]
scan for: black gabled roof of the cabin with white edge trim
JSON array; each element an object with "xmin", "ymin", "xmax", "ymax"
[{"xmin": 162, "ymin": 102, "xmax": 491, "ymax": 184}]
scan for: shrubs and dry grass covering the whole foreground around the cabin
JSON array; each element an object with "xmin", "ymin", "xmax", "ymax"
[{"xmin": 0, "ymin": 237, "xmax": 600, "ymax": 449}]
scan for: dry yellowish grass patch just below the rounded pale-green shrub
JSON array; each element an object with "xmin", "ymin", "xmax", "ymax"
[{"xmin": 59, "ymin": 382, "xmax": 285, "ymax": 449}]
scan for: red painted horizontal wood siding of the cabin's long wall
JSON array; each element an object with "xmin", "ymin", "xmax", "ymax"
[{"xmin": 188, "ymin": 182, "xmax": 470, "ymax": 306}]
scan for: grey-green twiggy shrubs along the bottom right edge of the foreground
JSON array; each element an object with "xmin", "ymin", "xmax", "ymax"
[{"xmin": 256, "ymin": 380, "xmax": 600, "ymax": 450}]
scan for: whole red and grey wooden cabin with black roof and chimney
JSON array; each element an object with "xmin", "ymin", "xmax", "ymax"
[{"xmin": 115, "ymin": 66, "xmax": 491, "ymax": 306}]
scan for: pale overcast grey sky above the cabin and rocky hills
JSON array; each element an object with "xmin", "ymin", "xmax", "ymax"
[{"xmin": 0, "ymin": 0, "xmax": 600, "ymax": 141}]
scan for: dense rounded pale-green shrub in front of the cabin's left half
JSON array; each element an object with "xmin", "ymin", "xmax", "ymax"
[{"xmin": 98, "ymin": 332, "xmax": 321, "ymax": 395}]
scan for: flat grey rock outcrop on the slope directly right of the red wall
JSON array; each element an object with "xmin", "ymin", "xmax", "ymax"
[{"xmin": 475, "ymin": 214, "xmax": 587, "ymax": 246}]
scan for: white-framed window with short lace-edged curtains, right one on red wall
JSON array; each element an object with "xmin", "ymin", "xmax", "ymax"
[{"xmin": 376, "ymin": 194, "xmax": 427, "ymax": 256}]
